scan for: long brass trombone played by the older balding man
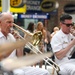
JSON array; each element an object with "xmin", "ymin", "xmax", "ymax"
[{"xmin": 13, "ymin": 24, "xmax": 60, "ymax": 73}]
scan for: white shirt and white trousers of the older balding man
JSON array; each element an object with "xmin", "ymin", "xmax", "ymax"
[{"xmin": 0, "ymin": 32, "xmax": 49, "ymax": 75}]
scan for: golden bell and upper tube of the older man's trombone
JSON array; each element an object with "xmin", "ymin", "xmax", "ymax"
[{"xmin": 13, "ymin": 23, "xmax": 42, "ymax": 46}]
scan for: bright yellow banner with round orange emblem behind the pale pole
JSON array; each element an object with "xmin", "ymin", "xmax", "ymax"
[{"xmin": 0, "ymin": 0, "xmax": 26, "ymax": 13}]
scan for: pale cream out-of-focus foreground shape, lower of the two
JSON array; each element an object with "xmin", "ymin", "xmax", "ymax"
[{"xmin": 1, "ymin": 52, "xmax": 52, "ymax": 71}]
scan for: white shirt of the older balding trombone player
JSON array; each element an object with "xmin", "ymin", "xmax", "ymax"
[{"xmin": 0, "ymin": 32, "xmax": 16, "ymax": 57}]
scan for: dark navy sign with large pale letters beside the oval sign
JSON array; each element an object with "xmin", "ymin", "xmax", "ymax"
[{"xmin": 26, "ymin": 0, "xmax": 43, "ymax": 13}]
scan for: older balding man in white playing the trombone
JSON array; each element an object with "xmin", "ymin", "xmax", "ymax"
[{"xmin": 0, "ymin": 12, "xmax": 49, "ymax": 75}]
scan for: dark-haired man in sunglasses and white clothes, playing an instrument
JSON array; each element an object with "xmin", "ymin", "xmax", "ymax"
[{"xmin": 51, "ymin": 13, "xmax": 75, "ymax": 75}]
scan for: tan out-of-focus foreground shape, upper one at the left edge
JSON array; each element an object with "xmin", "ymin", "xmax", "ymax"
[{"xmin": 0, "ymin": 40, "xmax": 26, "ymax": 55}]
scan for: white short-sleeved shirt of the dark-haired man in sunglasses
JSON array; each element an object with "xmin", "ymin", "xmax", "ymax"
[{"xmin": 51, "ymin": 30, "xmax": 73, "ymax": 64}]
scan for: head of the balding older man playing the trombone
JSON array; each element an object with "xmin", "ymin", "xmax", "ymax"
[{"xmin": 0, "ymin": 12, "xmax": 14, "ymax": 36}]
